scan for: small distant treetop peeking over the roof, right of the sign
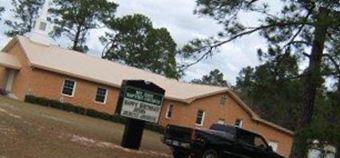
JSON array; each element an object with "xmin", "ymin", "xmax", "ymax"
[{"xmin": 191, "ymin": 69, "xmax": 228, "ymax": 87}]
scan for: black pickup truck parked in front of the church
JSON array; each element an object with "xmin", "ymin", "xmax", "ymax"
[{"xmin": 162, "ymin": 124, "xmax": 284, "ymax": 158}]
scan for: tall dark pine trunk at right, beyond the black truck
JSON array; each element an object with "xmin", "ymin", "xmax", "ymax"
[{"xmin": 292, "ymin": 7, "xmax": 329, "ymax": 158}]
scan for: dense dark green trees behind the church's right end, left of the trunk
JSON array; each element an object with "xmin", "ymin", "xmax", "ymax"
[{"xmin": 235, "ymin": 56, "xmax": 302, "ymax": 130}]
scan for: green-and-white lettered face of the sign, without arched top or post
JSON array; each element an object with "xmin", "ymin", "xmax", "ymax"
[{"xmin": 120, "ymin": 80, "xmax": 164, "ymax": 123}]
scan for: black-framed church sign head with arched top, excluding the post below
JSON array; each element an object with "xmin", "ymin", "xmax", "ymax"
[{"xmin": 116, "ymin": 80, "xmax": 165, "ymax": 123}]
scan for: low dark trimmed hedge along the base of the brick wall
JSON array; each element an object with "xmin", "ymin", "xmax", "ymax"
[{"xmin": 25, "ymin": 95, "xmax": 163, "ymax": 133}]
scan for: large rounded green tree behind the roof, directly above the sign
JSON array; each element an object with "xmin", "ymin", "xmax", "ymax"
[{"xmin": 100, "ymin": 14, "xmax": 180, "ymax": 79}]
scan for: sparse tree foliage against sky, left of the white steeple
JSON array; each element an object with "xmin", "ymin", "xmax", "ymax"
[{"xmin": 5, "ymin": 0, "xmax": 45, "ymax": 37}]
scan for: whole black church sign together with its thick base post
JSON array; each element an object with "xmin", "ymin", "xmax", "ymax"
[{"xmin": 116, "ymin": 80, "xmax": 165, "ymax": 150}]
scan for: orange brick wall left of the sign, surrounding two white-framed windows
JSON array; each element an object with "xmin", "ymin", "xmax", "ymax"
[{"xmin": 28, "ymin": 69, "xmax": 119, "ymax": 114}]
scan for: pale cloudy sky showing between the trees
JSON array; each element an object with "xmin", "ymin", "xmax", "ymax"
[{"xmin": 0, "ymin": 0, "xmax": 266, "ymax": 84}]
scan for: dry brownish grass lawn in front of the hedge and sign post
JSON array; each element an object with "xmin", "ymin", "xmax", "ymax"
[{"xmin": 0, "ymin": 97, "xmax": 170, "ymax": 158}]
